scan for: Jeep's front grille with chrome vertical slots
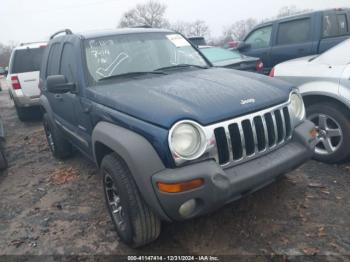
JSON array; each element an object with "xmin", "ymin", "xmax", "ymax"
[{"xmin": 213, "ymin": 104, "xmax": 292, "ymax": 166}]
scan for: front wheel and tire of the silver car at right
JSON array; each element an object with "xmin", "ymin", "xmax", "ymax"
[{"xmin": 306, "ymin": 102, "xmax": 350, "ymax": 164}]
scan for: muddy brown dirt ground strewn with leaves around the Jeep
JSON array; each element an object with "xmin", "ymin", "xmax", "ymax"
[{"xmin": 0, "ymin": 80, "xmax": 350, "ymax": 261}]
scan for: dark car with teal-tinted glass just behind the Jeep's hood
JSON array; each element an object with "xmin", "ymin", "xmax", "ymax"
[{"xmin": 199, "ymin": 46, "xmax": 264, "ymax": 73}]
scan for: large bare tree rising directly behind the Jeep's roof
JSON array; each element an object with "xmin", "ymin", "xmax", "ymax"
[{"xmin": 118, "ymin": 0, "xmax": 168, "ymax": 28}]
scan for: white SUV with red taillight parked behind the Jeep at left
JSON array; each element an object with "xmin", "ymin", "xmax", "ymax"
[{"xmin": 7, "ymin": 42, "xmax": 47, "ymax": 121}]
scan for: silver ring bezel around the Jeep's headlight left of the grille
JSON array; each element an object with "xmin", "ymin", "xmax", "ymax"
[{"xmin": 168, "ymin": 120, "xmax": 207, "ymax": 165}]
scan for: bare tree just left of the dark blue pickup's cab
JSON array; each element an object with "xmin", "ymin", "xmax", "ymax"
[{"xmin": 224, "ymin": 18, "xmax": 258, "ymax": 41}]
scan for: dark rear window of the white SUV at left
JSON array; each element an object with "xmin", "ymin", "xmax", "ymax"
[{"xmin": 11, "ymin": 48, "xmax": 45, "ymax": 74}]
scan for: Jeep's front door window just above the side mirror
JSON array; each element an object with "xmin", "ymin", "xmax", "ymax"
[{"xmin": 60, "ymin": 43, "xmax": 77, "ymax": 82}]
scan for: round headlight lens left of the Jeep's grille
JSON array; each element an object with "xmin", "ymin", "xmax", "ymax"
[{"xmin": 169, "ymin": 123, "xmax": 203, "ymax": 159}]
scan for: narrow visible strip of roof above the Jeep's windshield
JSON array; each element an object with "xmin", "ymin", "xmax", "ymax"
[{"xmin": 77, "ymin": 28, "xmax": 174, "ymax": 39}]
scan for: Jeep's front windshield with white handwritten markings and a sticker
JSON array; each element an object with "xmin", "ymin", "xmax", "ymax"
[{"xmin": 85, "ymin": 33, "xmax": 208, "ymax": 81}]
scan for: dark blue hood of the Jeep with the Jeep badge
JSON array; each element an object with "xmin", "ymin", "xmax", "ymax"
[{"xmin": 87, "ymin": 68, "xmax": 292, "ymax": 128}]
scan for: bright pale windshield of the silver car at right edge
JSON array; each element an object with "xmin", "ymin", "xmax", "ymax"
[{"xmin": 313, "ymin": 40, "xmax": 350, "ymax": 65}]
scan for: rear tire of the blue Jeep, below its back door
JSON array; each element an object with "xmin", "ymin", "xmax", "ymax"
[{"xmin": 43, "ymin": 113, "xmax": 73, "ymax": 159}]
